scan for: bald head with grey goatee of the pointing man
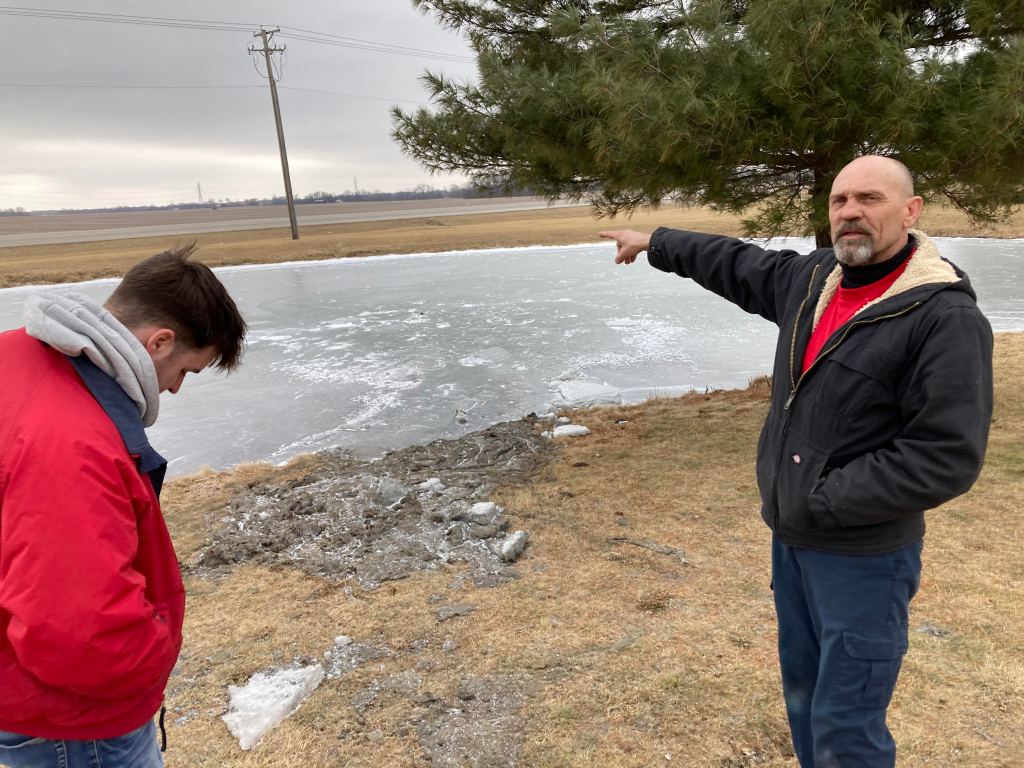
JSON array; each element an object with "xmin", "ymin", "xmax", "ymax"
[{"xmin": 828, "ymin": 155, "xmax": 923, "ymax": 266}]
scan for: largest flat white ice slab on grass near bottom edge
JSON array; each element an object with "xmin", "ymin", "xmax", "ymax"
[{"xmin": 222, "ymin": 664, "xmax": 325, "ymax": 750}]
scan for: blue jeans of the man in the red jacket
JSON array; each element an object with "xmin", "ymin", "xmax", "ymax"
[{"xmin": 0, "ymin": 720, "xmax": 164, "ymax": 768}]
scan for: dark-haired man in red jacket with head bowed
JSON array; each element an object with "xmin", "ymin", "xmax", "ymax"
[{"xmin": 0, "ymin": 247, "xmax": 246, "ymax": 768}]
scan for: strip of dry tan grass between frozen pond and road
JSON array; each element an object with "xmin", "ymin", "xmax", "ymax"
[{"xmin": 0, "ymin": 201, "xmax": 1024, "ymax": 288}]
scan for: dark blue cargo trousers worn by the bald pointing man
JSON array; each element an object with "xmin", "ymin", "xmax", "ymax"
[{"xmin": 772, "ymin": 539, "xmax": 922, "ymax": 768}]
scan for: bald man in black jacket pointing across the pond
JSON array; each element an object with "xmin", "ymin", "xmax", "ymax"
[{"xmin": 601, "ymin": 156, "xmax": 992, "ymax": 768}]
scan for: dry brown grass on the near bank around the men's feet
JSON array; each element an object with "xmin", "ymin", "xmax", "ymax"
[{"xmin": 159, "ymin": 335, "xmax": 1024, "ymax": 768}]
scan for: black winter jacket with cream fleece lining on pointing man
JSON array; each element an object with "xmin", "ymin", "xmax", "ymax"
[{"xmin": 648, "ymin": 227, "xmax": 992, "ymax": 553}]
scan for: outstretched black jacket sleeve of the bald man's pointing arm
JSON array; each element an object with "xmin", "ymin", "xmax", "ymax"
[{"xmin": 647, "ymin": 226, "xmax": 813, "ymax": 325}]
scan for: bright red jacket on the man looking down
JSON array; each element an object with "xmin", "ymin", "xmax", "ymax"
[{"xmin": 0, "ymin": 330, "xmax": 184, "ymax": 739}]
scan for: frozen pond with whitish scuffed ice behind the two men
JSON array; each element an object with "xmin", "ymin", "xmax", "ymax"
[{"xmin": 0, "ymin": 239, "xmax": 1024, "ymax": 474}]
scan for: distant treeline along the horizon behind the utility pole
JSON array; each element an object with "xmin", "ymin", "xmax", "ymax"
[{"xmin": 0, "ymin": 184, "xmax": 537, "ymax": 216}]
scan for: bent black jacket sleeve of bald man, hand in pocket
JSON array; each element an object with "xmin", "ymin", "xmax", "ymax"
[{"xmin": 809, "ymin": 306, "xmax": 992, "ymax": 527}]
